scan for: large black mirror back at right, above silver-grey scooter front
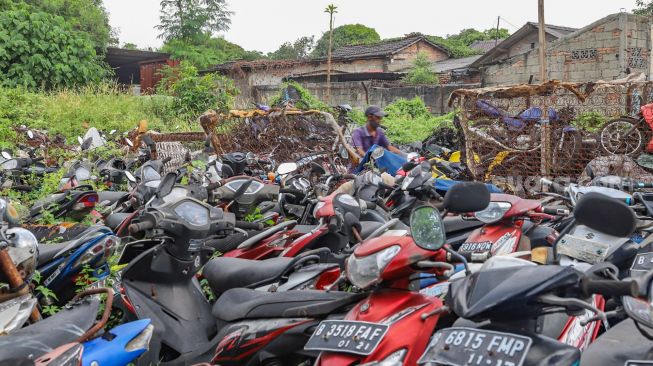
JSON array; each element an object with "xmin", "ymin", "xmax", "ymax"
[{"xmin": 574, "ymin": 192, "xmax": 637, "ymax": 238}]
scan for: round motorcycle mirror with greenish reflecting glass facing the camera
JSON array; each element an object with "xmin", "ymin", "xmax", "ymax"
[{"xmin": 410, "ymin": 206, "xmax": 447, "ymax": 250}]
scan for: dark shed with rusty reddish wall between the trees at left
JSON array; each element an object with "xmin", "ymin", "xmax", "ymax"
[{"xmin": 105, "ymin": 47, "xmax": 179, "ymax": 94}]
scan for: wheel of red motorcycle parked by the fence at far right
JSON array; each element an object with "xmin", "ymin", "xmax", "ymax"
[{"xmin": 599, "ymin": 118, "xmax": 645, "ymax": 156}]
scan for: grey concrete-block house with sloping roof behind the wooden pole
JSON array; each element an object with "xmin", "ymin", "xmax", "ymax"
[{"xmin": 471, "ymin": 13, "xmax": 651, "ymax": 86}]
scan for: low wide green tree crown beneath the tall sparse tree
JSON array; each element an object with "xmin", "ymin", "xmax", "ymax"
[{"xmin": 161, "ymin": 34, "xmax": 263, "ymax": 70}]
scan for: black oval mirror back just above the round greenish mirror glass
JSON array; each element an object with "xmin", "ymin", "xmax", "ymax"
[{"xmin": 442, "ymin": 182, "xmax": 490, "ymax": 213}]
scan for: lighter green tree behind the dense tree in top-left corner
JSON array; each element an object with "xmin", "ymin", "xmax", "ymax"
[{"xmin": 18, "ymin": 0, "xmax": 118, "ymax": 51}]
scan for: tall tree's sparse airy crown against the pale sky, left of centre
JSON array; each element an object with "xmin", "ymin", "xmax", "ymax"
[{"xmin": 156, "ymin": 0, "xmax": 233, "ymax": 41}]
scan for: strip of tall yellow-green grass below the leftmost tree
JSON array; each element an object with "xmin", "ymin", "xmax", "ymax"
[{"xmin": 0, "ymin": 84, "xmax": 199, "ymax": 146}]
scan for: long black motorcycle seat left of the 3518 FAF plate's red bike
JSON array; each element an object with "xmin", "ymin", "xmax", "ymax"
[{"xmin": 212, "ymin": 288, "xmax": 366, "ymax": 322}]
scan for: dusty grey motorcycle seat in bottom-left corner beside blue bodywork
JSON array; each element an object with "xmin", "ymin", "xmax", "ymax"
[{"xmin": 0, "ymin": 297, "xmax": 100, "ymax": 365}]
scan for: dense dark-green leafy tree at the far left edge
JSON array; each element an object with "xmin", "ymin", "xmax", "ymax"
[{"xmin": 0, "ymin": 4, "xmax": 106, "ymax": 89}]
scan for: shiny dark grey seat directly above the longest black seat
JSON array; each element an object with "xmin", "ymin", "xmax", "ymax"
[{"xmin": 202, "ymin": 257, "xmax": 293, "ymax": 296}]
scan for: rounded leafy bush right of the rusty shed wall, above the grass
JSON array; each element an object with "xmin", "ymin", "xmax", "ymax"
[{"xmin": 158, "ymin": 62, "xmax": 239, "ymax": 120}]
